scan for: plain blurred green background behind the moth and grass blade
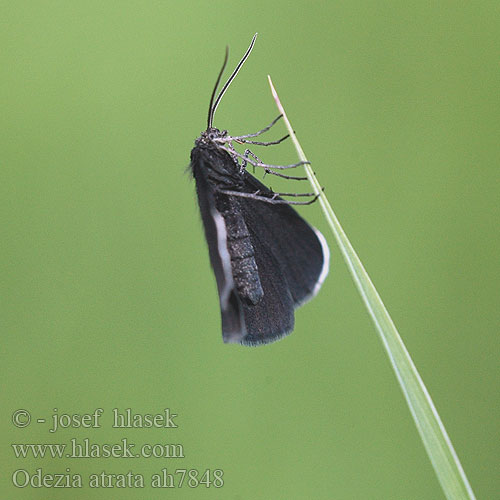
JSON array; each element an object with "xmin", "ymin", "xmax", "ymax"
[{"xmin": 0, "ymin": 0, "xmax": 500, "ymax": 500}]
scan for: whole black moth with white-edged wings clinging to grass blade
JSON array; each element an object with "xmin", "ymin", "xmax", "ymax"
[{"xmin": 190, "ymin": 35, "xmax": 329, "ymax": 345}]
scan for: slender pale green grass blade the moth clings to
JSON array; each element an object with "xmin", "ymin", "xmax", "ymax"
[{"xmin": 268, "ymin": 76, "xmax": 475, "ymax": 500}]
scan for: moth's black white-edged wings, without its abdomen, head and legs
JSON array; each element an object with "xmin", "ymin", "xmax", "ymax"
[{"xmin": 192, "ymin": 152, "xmax": 328, "ymax": 345}]
